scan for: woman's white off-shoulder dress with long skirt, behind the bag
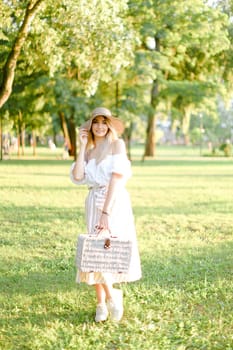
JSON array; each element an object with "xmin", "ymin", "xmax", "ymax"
[{"xmin": 70, "ymin": 154, "xmax": 141, "ymax": 284}]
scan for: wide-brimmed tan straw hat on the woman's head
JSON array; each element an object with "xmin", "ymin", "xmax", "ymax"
[{"xmin": 80, "ymin": 107, "xmax": 125, "ymax": 135}]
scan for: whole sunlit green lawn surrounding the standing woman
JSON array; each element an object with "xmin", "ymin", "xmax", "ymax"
[{"xmin": 0, "ymin": 148, "xmax": 233, "ymax": 350}]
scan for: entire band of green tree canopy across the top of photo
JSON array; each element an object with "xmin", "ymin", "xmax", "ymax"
[{"xmin": 0, "ymin": 0, "xmax": 233, "ymax": 156}]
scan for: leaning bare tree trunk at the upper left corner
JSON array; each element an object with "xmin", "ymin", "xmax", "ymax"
[{"xmin": 0, "ymin": 0, "xmax": 43, "ymax": 108}]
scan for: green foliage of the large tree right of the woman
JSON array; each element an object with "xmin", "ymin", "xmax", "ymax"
[{"xmin": 124, "ymin": 0, "xmax": 230, "ymax": 146}]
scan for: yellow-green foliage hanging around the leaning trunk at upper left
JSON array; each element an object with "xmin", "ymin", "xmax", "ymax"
[{"xmin": 0, "ymin": 0, "xmax": 136, "ymax": 141}]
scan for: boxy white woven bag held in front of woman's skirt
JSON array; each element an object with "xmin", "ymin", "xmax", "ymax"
[{"xmin": 76, "ymin": 234, "xmax": 132, "ymax": 273}]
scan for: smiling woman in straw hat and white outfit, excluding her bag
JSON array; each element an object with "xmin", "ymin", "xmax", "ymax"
[{"xmin": 71, "ymin": 107, "xmax": 141, "ymax": 322}]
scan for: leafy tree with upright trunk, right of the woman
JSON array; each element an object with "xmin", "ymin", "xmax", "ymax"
[{"xmin": 129, "ymin": 0, "xmax": 228, "ymax": 156}]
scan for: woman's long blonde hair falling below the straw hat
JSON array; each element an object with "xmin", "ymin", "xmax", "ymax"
[{"xmin": 86, "ymin": 116, "xmax": 118, "ymax": 164}]
